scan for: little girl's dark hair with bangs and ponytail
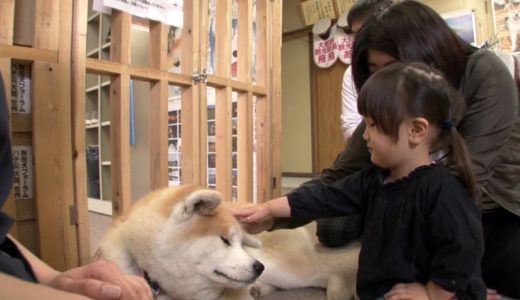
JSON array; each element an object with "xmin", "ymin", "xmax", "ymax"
[{"xmin": 358, "ymin": 62, "xmax": 476, "ymax": 197}]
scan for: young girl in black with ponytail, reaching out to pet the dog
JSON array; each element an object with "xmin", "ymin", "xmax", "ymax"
[{"xmin": 233, "ymin": 63, "xmax": 486, "ymax": 300}]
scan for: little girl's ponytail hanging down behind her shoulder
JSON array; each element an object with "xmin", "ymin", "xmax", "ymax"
[{"xmin": 443, "ymin": 125, "xmax": 477, "ymax": 199}]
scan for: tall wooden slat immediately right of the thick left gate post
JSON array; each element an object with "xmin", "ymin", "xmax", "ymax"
[{"xmin": 71, "ymin": 0, "xmax": 91, "ymax": 265}]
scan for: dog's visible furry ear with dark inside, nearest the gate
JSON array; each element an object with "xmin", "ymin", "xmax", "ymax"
[{"xmin": 173, "ymin": 189, "xmax": 221, "ymax": 219}]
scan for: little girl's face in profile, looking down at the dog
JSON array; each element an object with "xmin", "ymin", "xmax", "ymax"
[{"xmin": 363, "ymin": 116, "xmax": 409, "ymax": 170}]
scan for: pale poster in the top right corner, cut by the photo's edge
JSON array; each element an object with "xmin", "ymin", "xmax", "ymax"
[{"xmin": 493, "ymin": 0, "xmax": 520, "ymax": 52}]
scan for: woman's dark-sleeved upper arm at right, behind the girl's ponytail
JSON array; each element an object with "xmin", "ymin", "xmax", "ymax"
[{"xmin": 457, "ymin": 50, "xmax": 518, "ymax": 200}]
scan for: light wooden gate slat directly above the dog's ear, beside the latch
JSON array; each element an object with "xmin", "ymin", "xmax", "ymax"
[{"xmin": 181, "ymin": 1, "xmax": 202, "ymax": 185}]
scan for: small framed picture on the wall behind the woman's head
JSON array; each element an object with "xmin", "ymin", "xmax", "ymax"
[{"xmin": 441, "ymin": 10, "xmax": 477, "ymax": 46}]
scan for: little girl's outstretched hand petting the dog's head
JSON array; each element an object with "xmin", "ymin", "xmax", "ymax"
[{"xmin": 231, "ymin": 202, "xmax": 274, "ymax": 234}]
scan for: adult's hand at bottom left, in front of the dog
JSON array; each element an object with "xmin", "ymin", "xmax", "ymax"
[{"xmin": 48, "ymin": 260, "xmax": 153, "ymax": 300}]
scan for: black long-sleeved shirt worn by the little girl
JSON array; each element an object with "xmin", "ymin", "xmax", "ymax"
[{"xmin": 288, "ymin": 164, "xmax": 486, "ymax": 299}]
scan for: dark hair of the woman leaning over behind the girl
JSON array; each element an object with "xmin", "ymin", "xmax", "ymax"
[{"xmin": 352, "ymin": 0, "xmax": 472, "ymax": 90}]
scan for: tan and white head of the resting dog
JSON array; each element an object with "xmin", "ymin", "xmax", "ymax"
[{"xmin": 139, "ymin": 187, "xmax": 264, "ymax": 296}]
